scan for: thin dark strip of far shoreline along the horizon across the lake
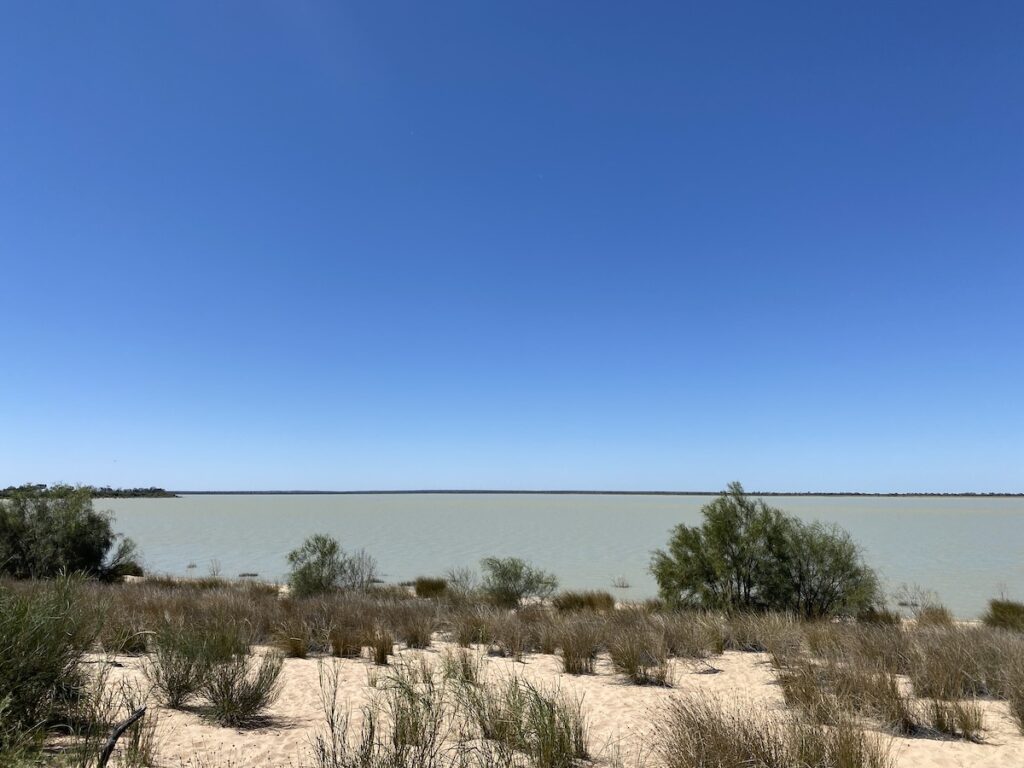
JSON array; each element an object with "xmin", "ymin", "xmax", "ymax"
[{"xmin": 170, "ymin": 488, "xmax": 1024, "ymax": 499}]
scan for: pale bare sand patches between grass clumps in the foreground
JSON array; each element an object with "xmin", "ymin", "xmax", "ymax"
[{"xmin": 103, "ymin": 643, "xmax": 1024, "ymax": 768}]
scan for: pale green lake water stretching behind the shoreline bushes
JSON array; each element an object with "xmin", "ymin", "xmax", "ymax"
[{"xmin": 97, "ymin": 494, "xmax": 1024, "ymax": 617}]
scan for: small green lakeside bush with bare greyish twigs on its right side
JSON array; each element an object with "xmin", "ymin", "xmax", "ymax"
[{"xmin": 288, "ymin": 534, "xmax": 377, "ymax": 597}]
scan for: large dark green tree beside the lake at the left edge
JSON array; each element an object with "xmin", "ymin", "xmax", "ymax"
[{"xmin": 0, "ymin": 485, "xmax": 142, "ymax": 579}]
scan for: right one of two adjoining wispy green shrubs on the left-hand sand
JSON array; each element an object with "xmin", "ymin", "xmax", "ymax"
[{"xmin": 201, "ymin": 653, "xmax": 283, "ymax": 727}]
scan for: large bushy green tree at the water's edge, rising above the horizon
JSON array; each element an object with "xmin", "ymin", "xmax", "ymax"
[{"xmin": 651, "ymin": 482, "xmax": 879, "ymax": 618}]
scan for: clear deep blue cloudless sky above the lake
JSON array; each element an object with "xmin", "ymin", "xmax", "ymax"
[{"xmin": 0, "ymin": 0, "xmax": 1024, "ymax": 492}]
